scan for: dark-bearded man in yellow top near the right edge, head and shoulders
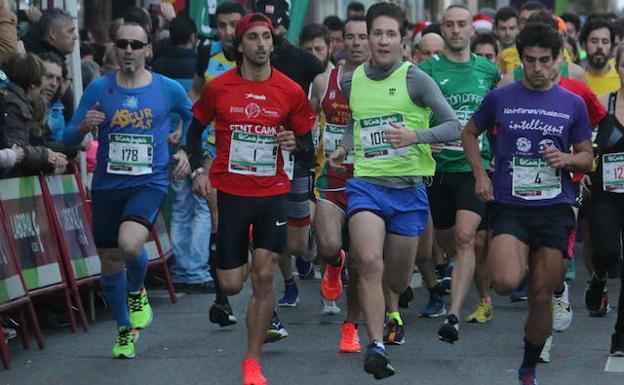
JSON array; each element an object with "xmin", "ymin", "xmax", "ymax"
[{"xmin": 581, "ymin": 18, "xmax": 620, "ymax": 96}]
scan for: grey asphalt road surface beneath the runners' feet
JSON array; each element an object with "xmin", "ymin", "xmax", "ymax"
[{"xmin": 0, "ymin": 258, "xmax": 624, "ymax": 385}]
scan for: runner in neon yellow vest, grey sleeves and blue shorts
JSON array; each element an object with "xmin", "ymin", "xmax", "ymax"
[{"xmin": 330, "ymin": 3, "xmax": 460, "ymax": 379}]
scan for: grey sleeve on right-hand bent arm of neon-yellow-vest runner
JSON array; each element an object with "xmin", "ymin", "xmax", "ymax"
[{"xmin": 407, "ymin": 66, "xmax": 462, "ymax": 143}]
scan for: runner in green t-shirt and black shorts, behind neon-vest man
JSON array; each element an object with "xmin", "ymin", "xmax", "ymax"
[{"xmin": 419, "ymin": 5, "xmax": 499, "ymax": 343}]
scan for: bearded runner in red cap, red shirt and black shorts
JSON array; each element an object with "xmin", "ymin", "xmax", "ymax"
[{"xmin": 187, "ymin": 13, "xmax": 314, "ymax": 385}]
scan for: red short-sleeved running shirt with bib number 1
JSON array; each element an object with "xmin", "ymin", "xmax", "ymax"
[{"xmin": 193, "ymin": 68, "xmax": 314, "ymax": 196}]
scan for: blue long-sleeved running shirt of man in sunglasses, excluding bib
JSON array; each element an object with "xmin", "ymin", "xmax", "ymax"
[{"xmin": 63, "ymin": 72, "xmax": 192, "ymax": 191}]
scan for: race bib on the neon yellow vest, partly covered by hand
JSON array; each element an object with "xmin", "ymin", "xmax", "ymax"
[{"xmin": 360, "ymin": 114, "xmax": 410, "ymax": 160}]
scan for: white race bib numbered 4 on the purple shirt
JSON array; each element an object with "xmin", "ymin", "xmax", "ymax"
[{"xmin": 512, "ymin": 157, "xmax": 561, "ymax": 201}]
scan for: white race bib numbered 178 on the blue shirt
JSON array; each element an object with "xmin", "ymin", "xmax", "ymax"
[{"xmin": 106, "ymin": 133, "xmax": 154, "ymax": 175}]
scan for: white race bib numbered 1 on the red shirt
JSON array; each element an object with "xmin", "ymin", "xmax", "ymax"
[{"xmin": 228, "ymin": 131, "xmax": 277, "ymax": 176}]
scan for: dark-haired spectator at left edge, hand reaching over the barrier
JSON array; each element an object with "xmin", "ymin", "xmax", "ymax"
[{"xmin": 3, "ymin": 53, "xmax": 67, "ymax": 175}]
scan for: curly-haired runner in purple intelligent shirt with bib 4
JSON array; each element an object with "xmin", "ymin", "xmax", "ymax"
[{"xmin": 462, "ymin": 23, "xmax": 593, "ymax": 385}]
